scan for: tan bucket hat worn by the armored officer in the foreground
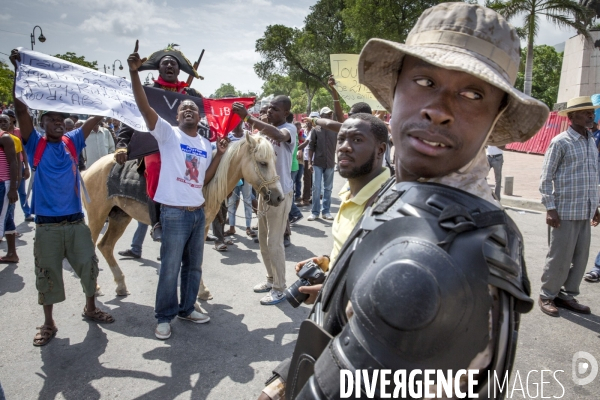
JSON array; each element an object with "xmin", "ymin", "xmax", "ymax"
[{"xmin": 358, "ymin": 3, "xmax": 549, "ymax": 146}]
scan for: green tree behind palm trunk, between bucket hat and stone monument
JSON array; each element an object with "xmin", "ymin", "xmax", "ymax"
[{"xmin": 515, "ymin": 45, "xmax": 563, "ymax": 110}]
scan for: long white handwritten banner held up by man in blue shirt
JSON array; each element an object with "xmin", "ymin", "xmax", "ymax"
[{"xmin": 15, "ymin": 48, "xmax": 148, "ymax": 131}]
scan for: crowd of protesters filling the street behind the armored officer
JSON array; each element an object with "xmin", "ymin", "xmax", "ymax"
[{"xmin": 0, "ymin": 17, "xmax": 600, "ymax": 356}]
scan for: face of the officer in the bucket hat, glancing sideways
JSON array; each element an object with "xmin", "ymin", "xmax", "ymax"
[{"xmin": 391, "ymin": 56, "xmax": 505, "ymax": 181}]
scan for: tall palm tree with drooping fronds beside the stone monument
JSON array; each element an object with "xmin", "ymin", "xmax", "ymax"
[{"xmin": 486, "ymin": 0, "xmax": 592, "ymax": 96}]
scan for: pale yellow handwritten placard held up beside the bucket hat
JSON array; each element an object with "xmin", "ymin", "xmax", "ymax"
[{"xmin": 329, "ymin": 54, "xmax": 384, "ymax": 110}]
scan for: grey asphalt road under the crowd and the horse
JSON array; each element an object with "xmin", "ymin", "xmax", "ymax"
[{"xmin": 0, "ymin": 175, "xmax": 600, "ymax": 400}]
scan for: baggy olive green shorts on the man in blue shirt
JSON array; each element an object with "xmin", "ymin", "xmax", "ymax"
[{"xmin": 33, "ymin": 220, "xmax": 98, "ymax": 305}]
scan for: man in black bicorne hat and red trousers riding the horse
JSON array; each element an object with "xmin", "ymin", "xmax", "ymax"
[{"xmin": 115, "ymin": 45, "xmax": 202, "ymax": 258}]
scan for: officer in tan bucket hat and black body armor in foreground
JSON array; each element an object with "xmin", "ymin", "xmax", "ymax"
[{"xmin": 261, "ymin": 3, "xmax": 548, "ymax": 400}]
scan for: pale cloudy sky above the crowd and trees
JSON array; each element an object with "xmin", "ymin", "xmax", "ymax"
[{"xmin": 0, "ymin": 0, "xmax": 574, "ymax": 96}]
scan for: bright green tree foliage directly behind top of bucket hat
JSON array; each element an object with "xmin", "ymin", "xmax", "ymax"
[{"xmin": 342, "ymin": 0, "xmax": 444, "ymax": 48}]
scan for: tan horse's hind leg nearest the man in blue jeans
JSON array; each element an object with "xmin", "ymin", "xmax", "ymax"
[{"xmin": 98, "ymin": 210, "xmax": 131, "ymax": 296}]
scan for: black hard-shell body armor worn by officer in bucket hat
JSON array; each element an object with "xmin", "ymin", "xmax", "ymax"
[{"xmin": 286, "ymin": 181, "xmax": 533, "ymax": 399}]
